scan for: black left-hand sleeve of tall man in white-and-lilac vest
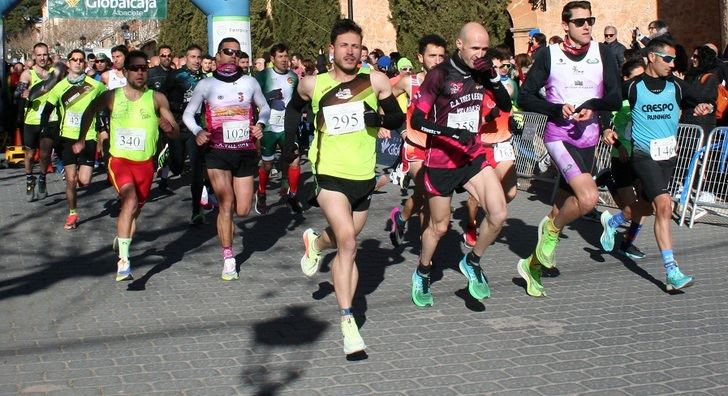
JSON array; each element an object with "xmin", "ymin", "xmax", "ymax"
[{"xmin": 518, "ymin": 50, "xmax": 564, "ymax": 118}]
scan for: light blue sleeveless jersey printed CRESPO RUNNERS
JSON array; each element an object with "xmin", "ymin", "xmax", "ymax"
[{"xmin": 632, "ymin": 81, "xmax": 680, "ymax": 154}]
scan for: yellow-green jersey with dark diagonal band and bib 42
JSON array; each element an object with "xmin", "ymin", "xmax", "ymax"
[{"xmin": 48, "ymin": 76, "xmax": 106, "ymax": 140}]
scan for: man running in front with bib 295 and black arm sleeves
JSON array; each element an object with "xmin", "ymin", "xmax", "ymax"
[{"xmin": 283, "ymin": 19, "xmax": 405, "ymax": 355}]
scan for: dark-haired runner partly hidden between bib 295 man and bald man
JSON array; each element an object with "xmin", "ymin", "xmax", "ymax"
[{"xmin": 389, "ymin": 34, "xmax": 447, "ymax": 245}]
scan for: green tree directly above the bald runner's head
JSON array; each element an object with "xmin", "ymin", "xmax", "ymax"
[{"xmin": 389, "ymin": 0, "xmax": 510, "ymax": 59}]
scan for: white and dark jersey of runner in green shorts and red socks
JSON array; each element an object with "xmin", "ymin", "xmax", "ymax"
[{"xmin": 255, "ymin": 68, "xmax": 298, "ymax": 133}]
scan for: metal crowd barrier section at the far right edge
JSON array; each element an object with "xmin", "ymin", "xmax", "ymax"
[{"xmin": 683, "ymin": 127, "xmax": 728, "ymax": 228}]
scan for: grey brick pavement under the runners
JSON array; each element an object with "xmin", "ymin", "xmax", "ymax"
[{"xmin": 0, "ymin": 163, "xmax": 728, "ymax": 396}]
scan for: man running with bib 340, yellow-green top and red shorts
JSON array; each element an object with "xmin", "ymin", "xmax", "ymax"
[{"xmin": 73, "ymin": 51, "xmax": 179, "ymax": 282}]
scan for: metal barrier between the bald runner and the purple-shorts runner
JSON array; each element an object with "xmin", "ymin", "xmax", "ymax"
[{"xmin": 511, "ymin": 111, "xmax": 559, "ymax": 201}]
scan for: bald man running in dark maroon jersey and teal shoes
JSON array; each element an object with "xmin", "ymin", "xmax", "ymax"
[{"xmin": 412, "ymin": 22, "xmax": 511, "ymax": 306}]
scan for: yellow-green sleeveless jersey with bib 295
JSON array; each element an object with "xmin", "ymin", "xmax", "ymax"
[{"xmin": 308, "ymin": 68, "xmax": 379, "ymax": 180}]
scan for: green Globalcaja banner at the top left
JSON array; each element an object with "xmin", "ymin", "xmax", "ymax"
[{"xmin": 48, "ymin": 0, "xmax": 167, "ymax": 19}]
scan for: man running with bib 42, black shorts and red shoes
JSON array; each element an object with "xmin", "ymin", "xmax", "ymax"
[{"xmin": 41, "ymin": 50, "xmax": 106, "ymax": 230}]
